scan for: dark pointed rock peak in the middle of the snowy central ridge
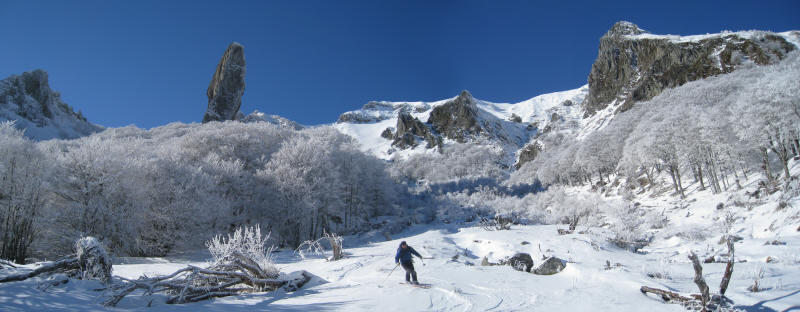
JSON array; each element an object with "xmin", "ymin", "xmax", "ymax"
[{"xmin": 428, "ymin": 90, "xmax": 482, "ymax": 143}]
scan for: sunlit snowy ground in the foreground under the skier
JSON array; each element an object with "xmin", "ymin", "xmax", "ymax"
[{"xmin": 0, "ymin": 221, "xmax": 800, "ymax": 311}]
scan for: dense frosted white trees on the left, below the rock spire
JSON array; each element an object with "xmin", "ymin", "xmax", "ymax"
[{"xmin": 0, "ymin": 122, "xmax": 404, "ymax": 262}]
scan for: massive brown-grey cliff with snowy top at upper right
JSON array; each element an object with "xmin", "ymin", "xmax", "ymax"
[{"xmin": 583, "ymin": 22, "xmax": 798, "ymax": 116}]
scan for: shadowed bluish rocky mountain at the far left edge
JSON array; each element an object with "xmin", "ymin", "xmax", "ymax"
[{"xmin": 0, "ymin": 69, "xmax": 103, "ymax": 140}]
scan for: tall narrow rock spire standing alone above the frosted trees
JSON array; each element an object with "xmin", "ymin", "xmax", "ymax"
[{"xmin": 203, "ymin": 42, "xmax": 246, "ymax": 123}]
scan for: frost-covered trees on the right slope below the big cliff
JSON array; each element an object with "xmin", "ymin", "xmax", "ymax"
[{"xmin": 511, "ymin": 52, "xmax": 800, "ymax": 196}]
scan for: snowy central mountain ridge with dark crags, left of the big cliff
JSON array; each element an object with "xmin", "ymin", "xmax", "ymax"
[{"xmin": 334, "ymin": 86, "xmax": 588, "ymax": 165}]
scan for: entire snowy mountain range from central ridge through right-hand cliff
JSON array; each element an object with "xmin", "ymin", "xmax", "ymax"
[{"xmin": 335, "ymin": 21, "xmax": 800, "ymax": 171}]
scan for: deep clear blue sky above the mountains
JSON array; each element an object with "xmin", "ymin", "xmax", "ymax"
[{"xmin": 0, "ymin": 0, "xmax": 800, "ymax": 128}]
